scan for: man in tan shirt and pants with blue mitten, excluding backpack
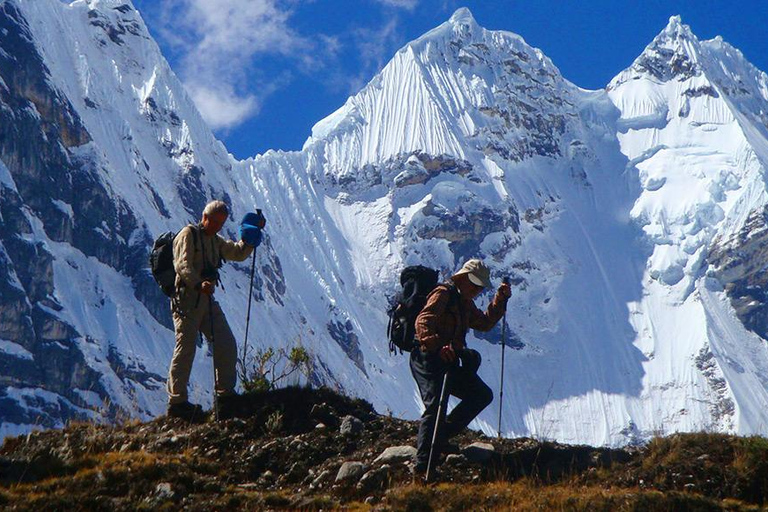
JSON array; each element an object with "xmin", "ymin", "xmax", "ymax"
[{"xmin": 167, "ymin": 201, "xmax": 266, "ymax": 419}]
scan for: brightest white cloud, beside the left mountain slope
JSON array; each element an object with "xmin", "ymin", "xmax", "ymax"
[{"xmin": 160, "ymin": 0, "xmax": 313, "ymax": 130}]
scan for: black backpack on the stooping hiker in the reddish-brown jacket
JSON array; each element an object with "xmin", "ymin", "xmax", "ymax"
[{"xmin": 387, "ymin": 265, "xmax": 439, "ymax": 354}]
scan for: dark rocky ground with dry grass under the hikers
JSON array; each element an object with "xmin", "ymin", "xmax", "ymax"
[{"xmin": 0, "ymin": 388, "xmax": 768, "ymax": 512}]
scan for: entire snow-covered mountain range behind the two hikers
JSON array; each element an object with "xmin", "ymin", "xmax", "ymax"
[{"xmin": 0, "ymin": 0, "xmax": 768, "ymax": 446}]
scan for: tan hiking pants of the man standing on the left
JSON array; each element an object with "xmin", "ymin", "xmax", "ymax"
[{"xmin": 167, "ymin": 295, "xmax": 237, "ymax": 404}]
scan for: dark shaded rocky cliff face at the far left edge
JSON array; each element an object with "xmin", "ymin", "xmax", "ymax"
[{"xmin": 0, "ymin": 2, "xmax": 131, "ymax": 427}]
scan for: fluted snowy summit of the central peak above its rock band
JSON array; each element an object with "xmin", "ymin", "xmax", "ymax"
[{"xmin": 304, "ymin": 9, "xmax": 575, "ymax": 181}]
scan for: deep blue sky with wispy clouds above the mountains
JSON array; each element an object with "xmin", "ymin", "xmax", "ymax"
[{"xmin": 134, "ymin": 0, "xmax": 768, "ymax": 158}]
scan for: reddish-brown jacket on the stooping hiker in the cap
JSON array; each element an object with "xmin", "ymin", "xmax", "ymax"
[{"xmin": 416, "ymin": 284, "xmax": 507, "ymax": 352}]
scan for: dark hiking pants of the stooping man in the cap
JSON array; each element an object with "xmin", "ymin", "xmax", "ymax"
[{"xmin": 411, "ymin": 347, "xmax": 493, "ymax": 467}]
